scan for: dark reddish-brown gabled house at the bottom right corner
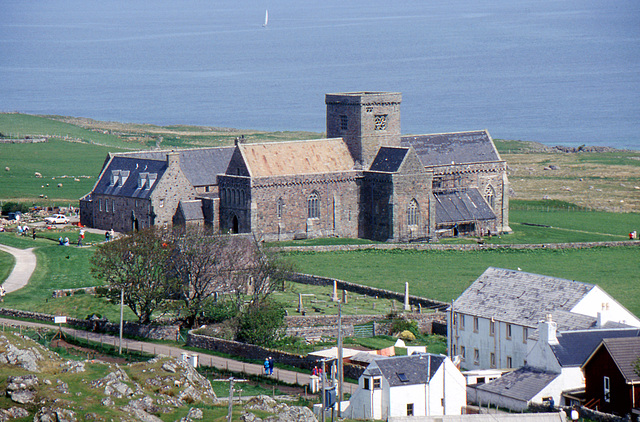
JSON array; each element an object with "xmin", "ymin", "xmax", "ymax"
[{"xmin": 582, "ymin": 337, "xmax": 640, "ymax": 420}]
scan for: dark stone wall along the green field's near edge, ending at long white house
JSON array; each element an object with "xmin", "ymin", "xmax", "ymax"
[{"xmin": 289, "ymin": 273, "xmax": 449, "ymax": 311}]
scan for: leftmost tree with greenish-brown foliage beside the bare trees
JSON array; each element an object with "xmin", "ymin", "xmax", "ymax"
[{"xmin": 91, "ymin": 228, "xmax": 175, "ymax": 324}]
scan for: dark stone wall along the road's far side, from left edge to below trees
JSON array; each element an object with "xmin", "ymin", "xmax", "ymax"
[{"xmin": 0, "ymin": 308, "xmax": 179, "ymax": 340}]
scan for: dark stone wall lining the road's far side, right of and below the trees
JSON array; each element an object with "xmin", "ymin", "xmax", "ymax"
[{"xmin": 187, "ymin": 331, "xmax": 365, "ymax": 379}]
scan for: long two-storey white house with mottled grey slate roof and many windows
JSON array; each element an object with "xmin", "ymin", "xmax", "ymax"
[{"xmin": 447, "ymin": 267, "xmax": 640, "ymax": 369}]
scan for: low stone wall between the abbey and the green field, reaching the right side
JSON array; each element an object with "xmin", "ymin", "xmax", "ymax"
[{"xmin": 274, "ymin": 240, "xmax": 640, "ymax": 252}]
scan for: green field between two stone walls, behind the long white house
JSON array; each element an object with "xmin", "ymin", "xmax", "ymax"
[{"xmin": 284, "ymin": 247, "xmax": 640, "ymax": 315}]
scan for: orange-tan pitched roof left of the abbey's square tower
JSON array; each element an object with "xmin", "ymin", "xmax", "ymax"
[{"xmin": 238, "ymin": 138, "xmax": 354, "ymax": 177}]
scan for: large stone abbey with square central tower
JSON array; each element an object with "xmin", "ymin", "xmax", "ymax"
[{"xmin": 80, "ymin": 92, "xmax": 510, "ymax": 242}]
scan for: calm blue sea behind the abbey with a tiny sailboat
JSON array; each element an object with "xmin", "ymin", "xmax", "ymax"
[{"xmin": 0, "ymin": 0, "xmax": 640, "ymax": 149}]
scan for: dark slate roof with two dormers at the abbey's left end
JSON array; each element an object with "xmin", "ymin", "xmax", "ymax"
[{"xmin": 92, "ymin": 155, "xmax": 167, "ymax": 199}]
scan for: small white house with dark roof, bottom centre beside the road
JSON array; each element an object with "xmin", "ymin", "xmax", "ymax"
[{"xmin": 343, "ymin": 353, "xmax": 467, "ymax": 420}]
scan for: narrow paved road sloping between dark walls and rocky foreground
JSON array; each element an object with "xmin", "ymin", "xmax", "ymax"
[{"xmin": 0, "ymin": 318, "xmax": 358, "ymax": 394}]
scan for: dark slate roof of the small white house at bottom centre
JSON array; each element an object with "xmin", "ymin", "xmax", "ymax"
[{"xmin": 365, "ymin": 353, "xmax": 446, "ymax": 387}]
